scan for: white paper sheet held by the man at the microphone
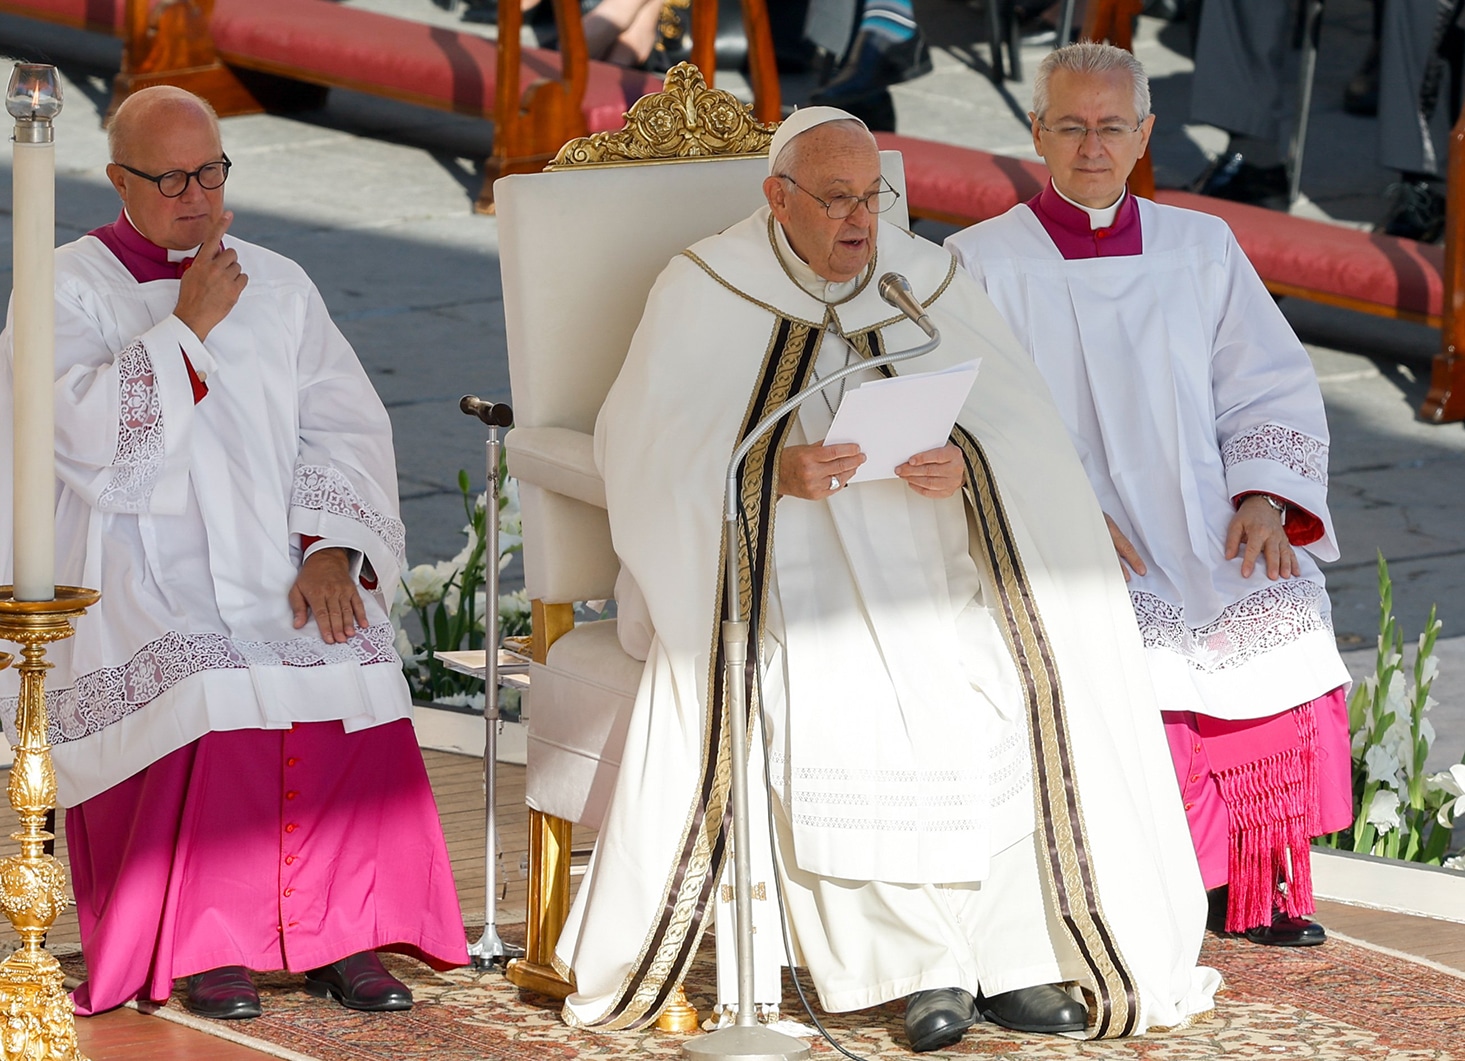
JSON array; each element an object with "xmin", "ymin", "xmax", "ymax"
[{"xmin": 825, "ymin": 358, "xmax": 982, "ymax": 482}]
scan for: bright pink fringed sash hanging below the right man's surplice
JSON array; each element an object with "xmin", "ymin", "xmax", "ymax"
[{"xmin": 1197, "ymin": 702, "xmax": 1323, "ymax": 932}]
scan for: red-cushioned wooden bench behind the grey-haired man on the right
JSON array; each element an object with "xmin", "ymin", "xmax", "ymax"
[{"xmin": 876, "ymin": 133, "xmax": 1465, "ymax": 422}]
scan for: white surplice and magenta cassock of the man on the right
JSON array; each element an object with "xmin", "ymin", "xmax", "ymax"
[{"xmin": 946, "ymin": 189, "xmax": 1352, "ymax": 929}]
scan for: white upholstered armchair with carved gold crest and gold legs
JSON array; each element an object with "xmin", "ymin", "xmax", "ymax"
[{"xmin": 494, "ymin": 64, "xmax": 907, "ymax": 998}]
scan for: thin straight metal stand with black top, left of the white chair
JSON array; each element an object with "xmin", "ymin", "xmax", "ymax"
[{"xmin": 459, "ymin": 394, "xmax": 524, "ymax": 969}]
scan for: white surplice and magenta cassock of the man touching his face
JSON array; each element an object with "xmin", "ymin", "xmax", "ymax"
[{"xmin": 0, "ymin": 214, "xmax": 466, "ymax": 1013}]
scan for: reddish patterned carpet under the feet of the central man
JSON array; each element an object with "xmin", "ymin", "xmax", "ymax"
[{"xmin": 64, "ymin": 926, "xmax": 1465, "ymax": 1061}]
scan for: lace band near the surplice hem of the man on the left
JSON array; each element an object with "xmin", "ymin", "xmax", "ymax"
[{"xmin": 0, "ymin": 623, "xmax": 401, "ymax": 744}]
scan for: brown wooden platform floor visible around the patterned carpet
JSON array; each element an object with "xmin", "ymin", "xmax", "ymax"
[{"xmin": 0, "ymin": 752, "xmax": 1465, "ymax": 1061}]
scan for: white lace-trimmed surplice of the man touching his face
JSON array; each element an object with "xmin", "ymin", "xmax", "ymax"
[{"xmin": 0, "ymin": 236, "xmax": 412, "ymax": 806}]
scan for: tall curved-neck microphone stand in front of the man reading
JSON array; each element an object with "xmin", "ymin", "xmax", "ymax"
[{"xmin": 681, "ymin": 285, "xmax": 941, "ymax": 1061}]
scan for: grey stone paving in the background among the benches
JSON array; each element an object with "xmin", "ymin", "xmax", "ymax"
[{"xmin": 0, "ymin": 0, "xmax": 1465, "ymax": 766}]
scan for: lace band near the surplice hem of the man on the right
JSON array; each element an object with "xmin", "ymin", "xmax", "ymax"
[{"xmin": 1130, "ymin": 579, "xmax": 1333, "ymax": 673}]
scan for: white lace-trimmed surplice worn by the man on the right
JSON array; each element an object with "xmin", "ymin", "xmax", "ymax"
[{"xmin": 946, "ymin": 198, "xmax": 1349, "ymax": 720}]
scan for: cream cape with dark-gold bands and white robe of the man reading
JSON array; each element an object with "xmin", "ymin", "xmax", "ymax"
[{"xmin": 557, "ymin": 208, "xmax": 1217, "ymax": 1036}]
